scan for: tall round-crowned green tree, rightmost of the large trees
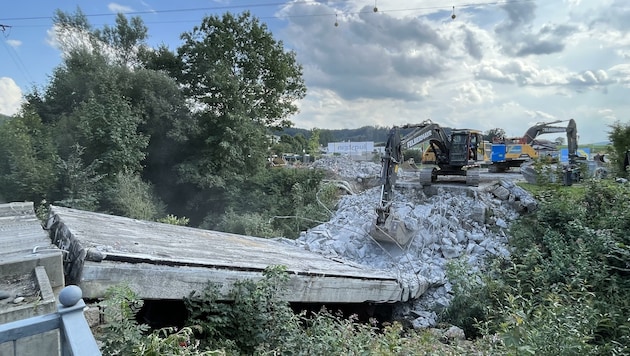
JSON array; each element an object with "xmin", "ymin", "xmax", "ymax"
[{"xmin": 178, "ymin": 12, "xmax": 306, "ymax": 192}]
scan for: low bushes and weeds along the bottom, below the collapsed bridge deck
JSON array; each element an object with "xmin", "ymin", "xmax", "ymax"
[{"xmin": 97, "ymin": 266, "xmax": 484, "ymax": 355}]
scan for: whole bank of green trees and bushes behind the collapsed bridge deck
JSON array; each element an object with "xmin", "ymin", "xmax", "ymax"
[{"xmin": 0, "ymin": 10, "xmax": 331, "ymax": 237}]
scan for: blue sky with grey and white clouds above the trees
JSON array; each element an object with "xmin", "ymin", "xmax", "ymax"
[{"xmin": 0, "ymin": 0, "xmax": 630, "ymax": 144}]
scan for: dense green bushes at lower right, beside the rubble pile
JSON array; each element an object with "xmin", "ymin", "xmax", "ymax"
[{"xmin": 447, "ymin": 180, "xmax": 630, "ymax": 355}]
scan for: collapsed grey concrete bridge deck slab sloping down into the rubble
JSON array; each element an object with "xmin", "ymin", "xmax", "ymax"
[{"xmin": 47, "ymin": 206, "xmax": 408, "ymax": 303}]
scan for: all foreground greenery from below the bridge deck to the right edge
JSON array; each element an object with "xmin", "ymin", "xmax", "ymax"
[{"xmin": 97, "ymin": 180, "xmax": 630, "ymax": 355}]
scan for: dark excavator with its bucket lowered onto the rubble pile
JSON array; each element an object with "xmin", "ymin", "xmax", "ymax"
[{"xmin": 371, "ymin": 120, "xmax": 484, "ymax": 245}]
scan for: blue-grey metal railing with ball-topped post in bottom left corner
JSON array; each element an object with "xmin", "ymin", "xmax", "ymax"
[{"xmin": 0, "ymin": 286, "xmax": 101, "ymax": 356}]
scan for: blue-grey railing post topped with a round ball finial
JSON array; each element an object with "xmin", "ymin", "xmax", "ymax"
[{"xmin": 58, "ymin": 285, "xmax": 101, "ymax": 356}]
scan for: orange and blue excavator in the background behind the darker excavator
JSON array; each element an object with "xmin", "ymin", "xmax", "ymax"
[{"xmin": 488, "ymin": 120, "xmax": 568, "ymax": 173}]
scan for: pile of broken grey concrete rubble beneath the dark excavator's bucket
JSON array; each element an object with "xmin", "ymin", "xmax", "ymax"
[{"xmin": 285, "ymin": 157, "xmax": 536, "ymax": 328}]
